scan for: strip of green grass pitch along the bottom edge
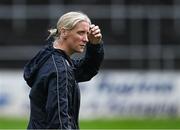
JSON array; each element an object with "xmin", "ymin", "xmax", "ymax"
[{"xmin": 0, "ymin": 118, "xmax": 180, "ymax": 129}]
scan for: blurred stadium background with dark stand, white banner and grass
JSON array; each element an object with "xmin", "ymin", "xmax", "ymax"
[{"xmin": 0, "ymin": 0, "xmax": 180, "ymax": 129}]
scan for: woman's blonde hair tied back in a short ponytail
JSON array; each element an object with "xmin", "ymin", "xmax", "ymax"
[{"xmin": 48, "ymin": 11, "xmax": 91, "ymax": 39}]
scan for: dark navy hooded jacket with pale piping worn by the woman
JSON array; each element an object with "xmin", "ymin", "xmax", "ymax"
[{"xmin": 24, "ymin": 41, "xmax": 104, "ymax": 129}]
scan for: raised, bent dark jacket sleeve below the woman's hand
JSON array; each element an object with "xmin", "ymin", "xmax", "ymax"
[{"xmin": 73, "ymin": 43, "xmax": 104, "ymax": 82}]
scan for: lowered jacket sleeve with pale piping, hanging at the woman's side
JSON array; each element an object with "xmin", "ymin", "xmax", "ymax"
[{"xmin": 46, "ymin": 57, "xmax": 69, "ymax": 129}]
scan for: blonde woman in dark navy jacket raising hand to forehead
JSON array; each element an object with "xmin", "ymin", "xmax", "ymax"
[{"xmin": 24, "ymin": 12, "xmax": 104, "ymax": 129}]
